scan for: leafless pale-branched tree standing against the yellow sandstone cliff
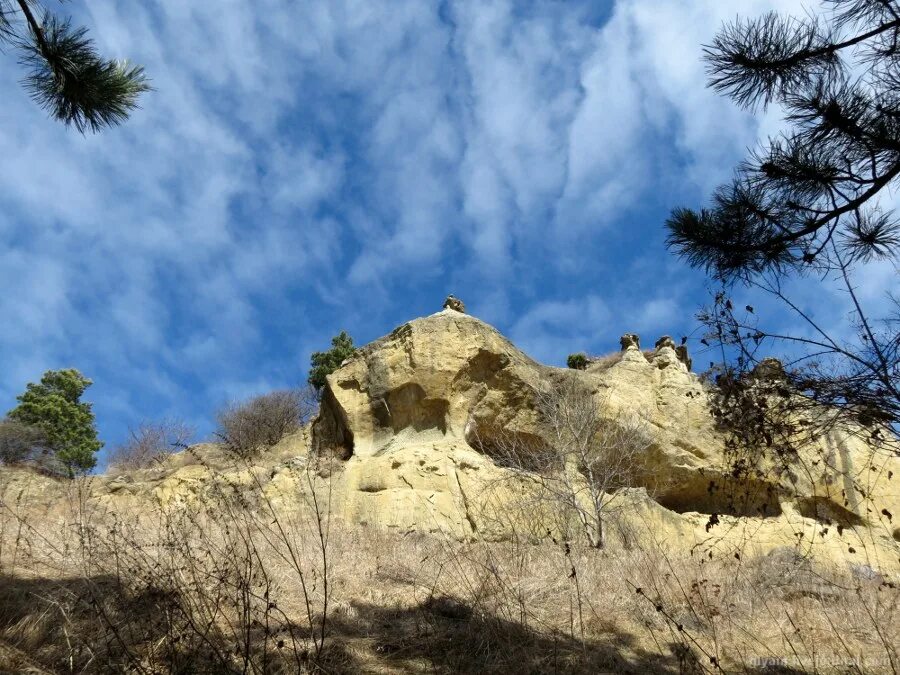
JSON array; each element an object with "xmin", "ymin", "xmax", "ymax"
[{"xmin": 489, "ymin": 377, "xmax": 651, "ymax": 548}]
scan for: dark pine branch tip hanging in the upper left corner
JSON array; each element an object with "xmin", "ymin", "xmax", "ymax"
[{"xmin": 0, "ymin": 0, "xmax": 150, "ymax": 133}]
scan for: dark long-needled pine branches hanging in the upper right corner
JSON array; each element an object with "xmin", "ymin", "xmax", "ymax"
[{"xmin": 668, "ymin": 0, "xmax": 900, "ymax": 279}]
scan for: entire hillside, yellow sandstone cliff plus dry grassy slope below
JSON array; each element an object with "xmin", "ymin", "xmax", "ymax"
[{"xmin": 0, "ymin": 309, "xmax": 900, "ymax": 672}]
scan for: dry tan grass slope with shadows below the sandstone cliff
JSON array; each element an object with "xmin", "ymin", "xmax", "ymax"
[{"xmin": 0, "ymin": 470, "xmax": 900, "ymax": 673}]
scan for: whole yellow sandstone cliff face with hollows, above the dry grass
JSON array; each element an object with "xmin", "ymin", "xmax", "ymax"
[{"xmin": 10, "ymin": 308, "xmax": 900, "ymax": 570}]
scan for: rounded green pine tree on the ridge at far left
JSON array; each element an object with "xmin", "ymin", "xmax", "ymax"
[{"xmin": 8, "ymin": 368, "xmax": 103, "ymax": 477}]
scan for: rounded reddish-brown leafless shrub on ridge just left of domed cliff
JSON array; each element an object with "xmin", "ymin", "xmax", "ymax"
[{"xmin": 216, "ymin": 390, "xmax": 308, "ymax": 457}]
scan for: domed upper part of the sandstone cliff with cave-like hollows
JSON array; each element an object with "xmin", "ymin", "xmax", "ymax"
[{"xmin": 313, "ymin": 309, "xmax": 551, "ymax": 457}]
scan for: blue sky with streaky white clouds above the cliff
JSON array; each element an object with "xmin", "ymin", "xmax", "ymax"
[{"xmin": 0, "ymin": 0, "xmax": 896, "ymax": 464}]
